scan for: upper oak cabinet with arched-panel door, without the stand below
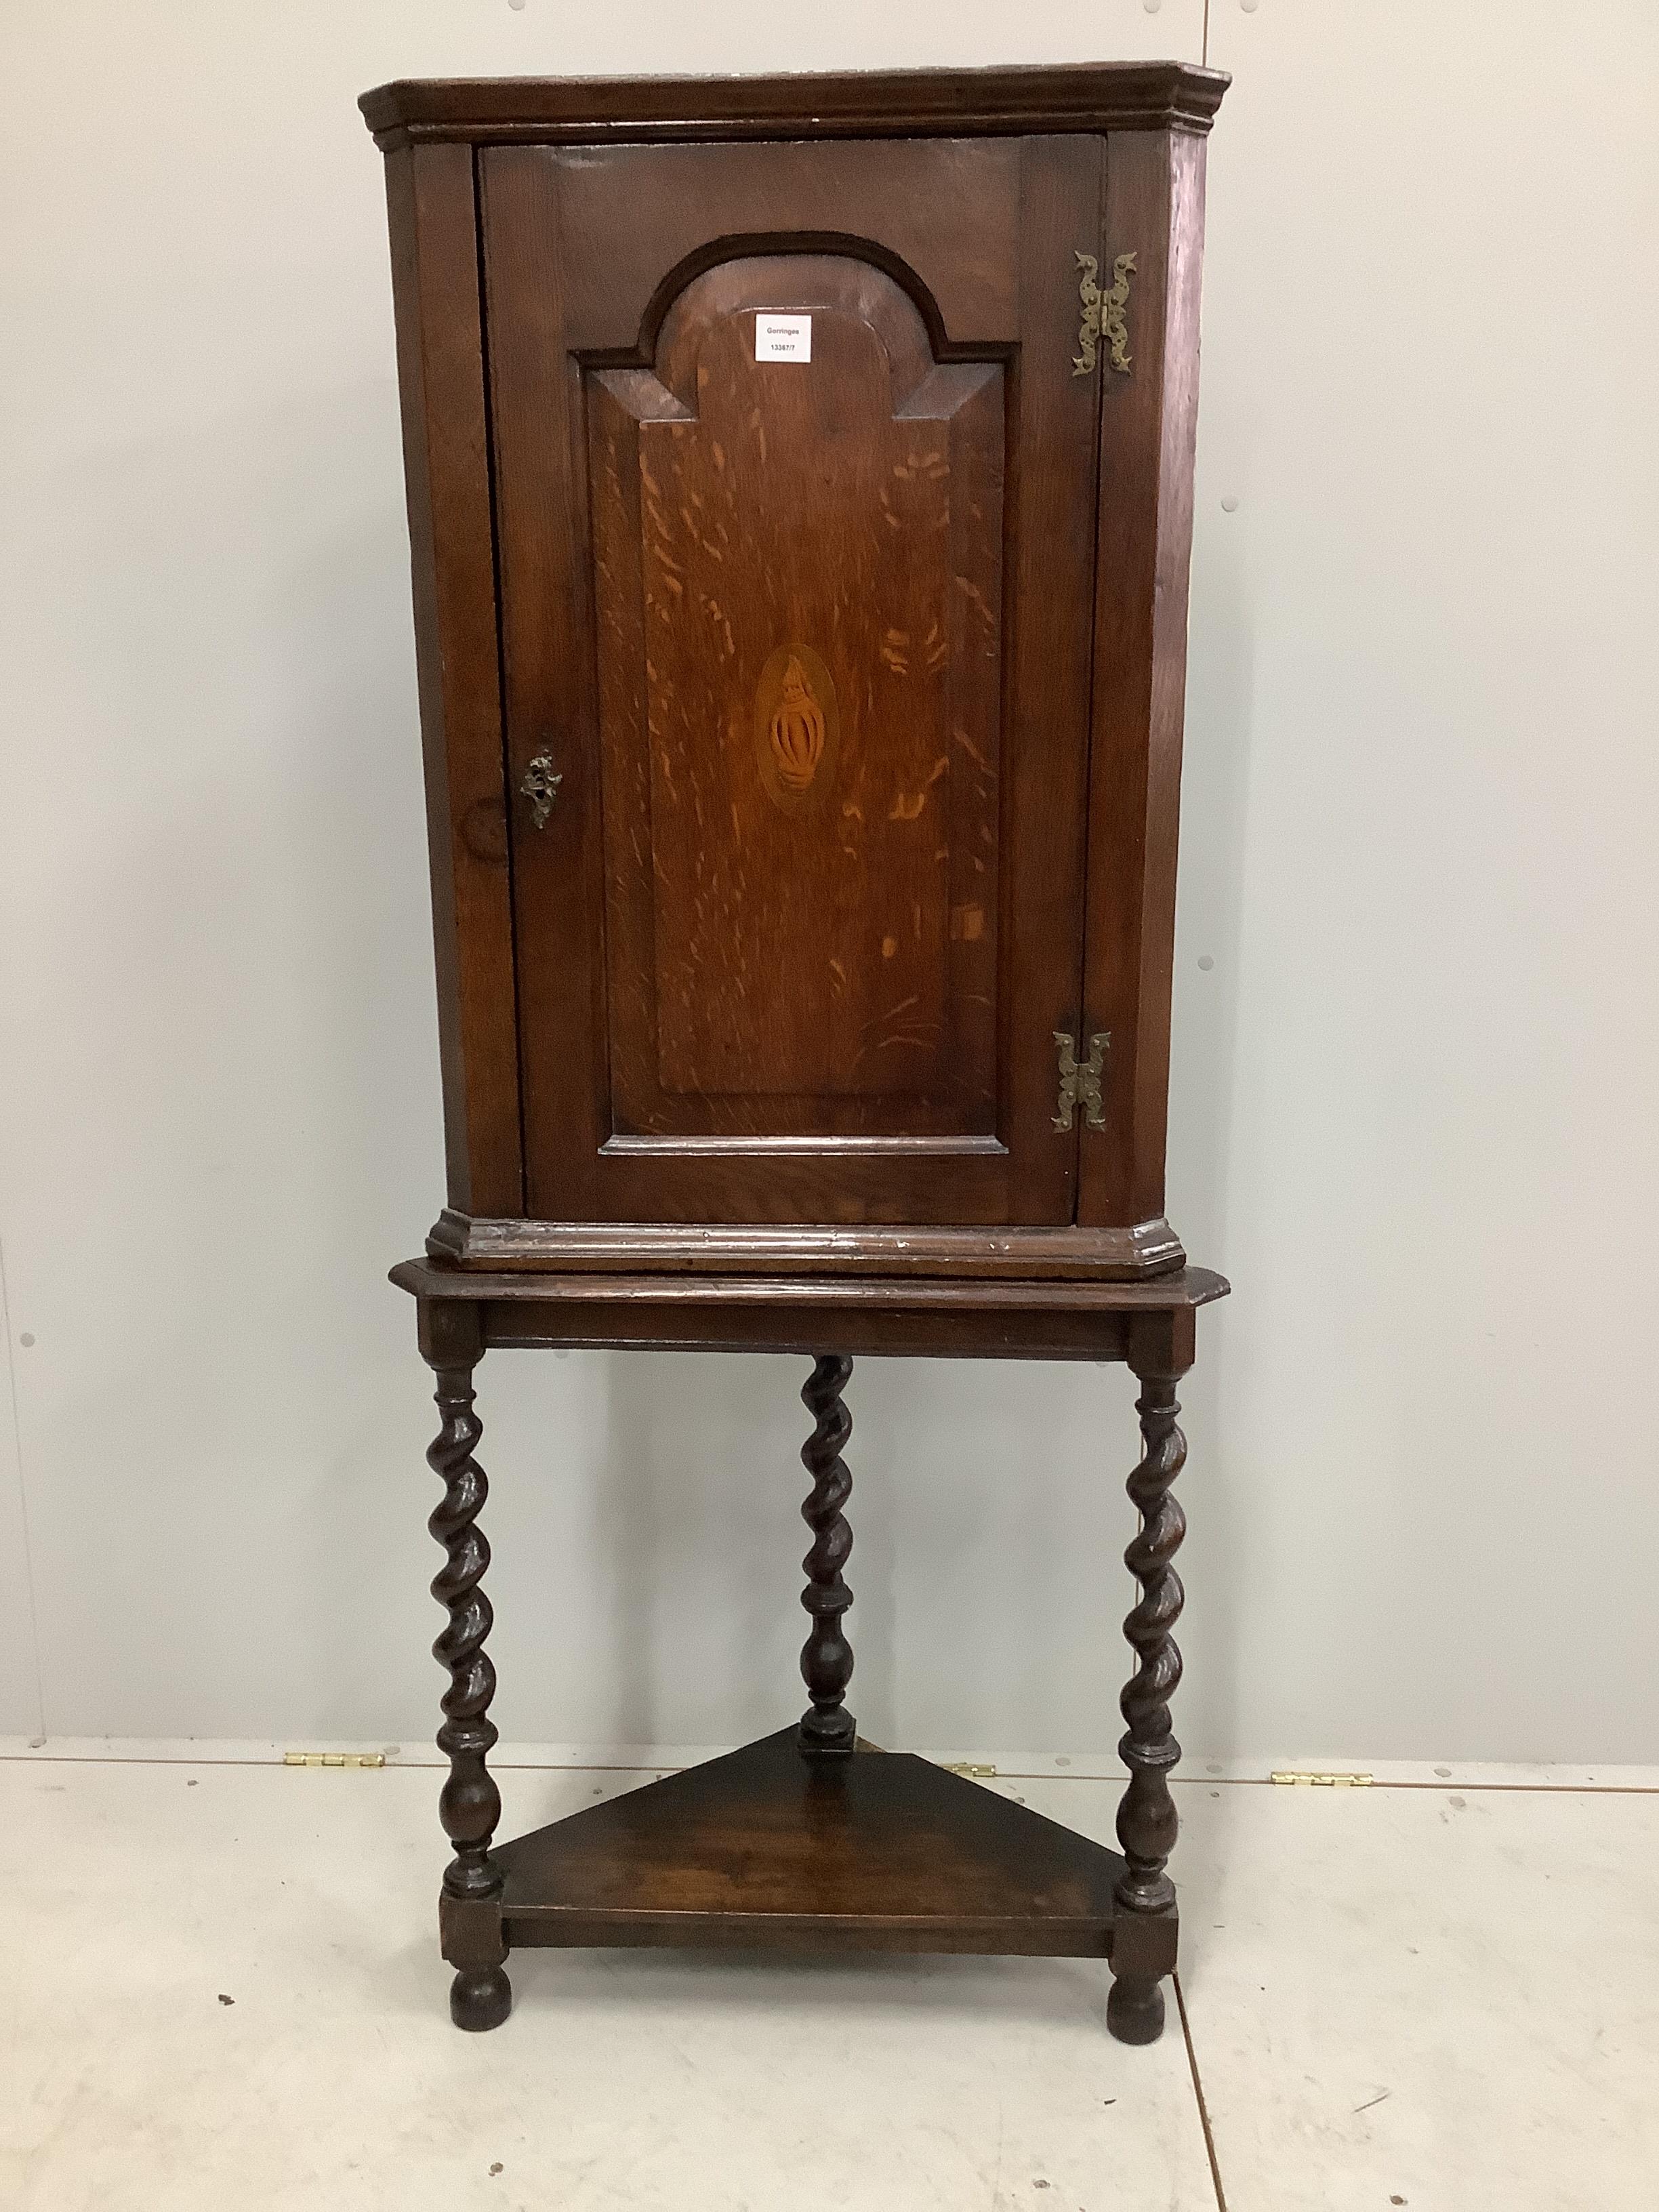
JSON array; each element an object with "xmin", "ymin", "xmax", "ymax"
[{"xmin": 365, "ymin": 64, "xmax": 1225, "ymax": 1276}]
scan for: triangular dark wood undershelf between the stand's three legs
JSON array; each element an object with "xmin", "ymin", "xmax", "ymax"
[{"xmin": 493, "ymin": 1727, "xmax": 1141, "ymax": 1958}]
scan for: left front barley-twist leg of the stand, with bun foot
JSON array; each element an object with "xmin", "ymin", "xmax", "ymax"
[{"xmin": 427, "ymin": 1300, "xmax": 513, "ymax": 2028}]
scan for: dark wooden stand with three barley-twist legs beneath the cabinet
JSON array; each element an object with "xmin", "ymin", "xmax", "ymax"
[{"xmin": 392, "ymin": 1261, "xmax": 1228, "ymax": 2044}]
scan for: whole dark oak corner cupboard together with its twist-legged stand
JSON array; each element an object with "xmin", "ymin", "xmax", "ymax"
[{"xmin": 363, "ymin": 62, "xmax": 1225, "ymax": 2042}]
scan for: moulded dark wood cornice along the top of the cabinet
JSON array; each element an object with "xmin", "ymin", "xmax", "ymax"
[{"xmin": 359, "ymin": 62, "xmax": 1230, "ymax": 146}]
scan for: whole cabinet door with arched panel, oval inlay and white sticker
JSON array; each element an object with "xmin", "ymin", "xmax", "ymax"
[{"xmin": 480, "ymin": 135, "xmax": 1101, "ymax": 1223}]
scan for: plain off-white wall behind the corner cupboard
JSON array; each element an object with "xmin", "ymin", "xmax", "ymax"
[{"xmin": 0, "ymin": 0, "xmax": 1659, "ymax": 1761}]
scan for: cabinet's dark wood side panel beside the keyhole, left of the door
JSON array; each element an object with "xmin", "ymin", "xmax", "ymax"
[{"xmin": 387, "ymin": 146, "xmax": 525, "ymax": 1214}]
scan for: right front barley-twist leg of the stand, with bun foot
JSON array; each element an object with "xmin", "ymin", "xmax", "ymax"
[{"xmin": 1106, "ymin": 1374, "xmax": 1186, "ymax": 2044}]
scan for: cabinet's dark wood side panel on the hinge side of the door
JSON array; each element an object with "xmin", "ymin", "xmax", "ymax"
[{"xmin": 1080, "ymin": 133, "xmax": 1206, "ymax": 1225}]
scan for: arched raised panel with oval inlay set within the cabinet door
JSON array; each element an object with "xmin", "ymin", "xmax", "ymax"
[{"xmin": 586, "ymin": 254, "xmax": 1006, "ymax": 1157}]
